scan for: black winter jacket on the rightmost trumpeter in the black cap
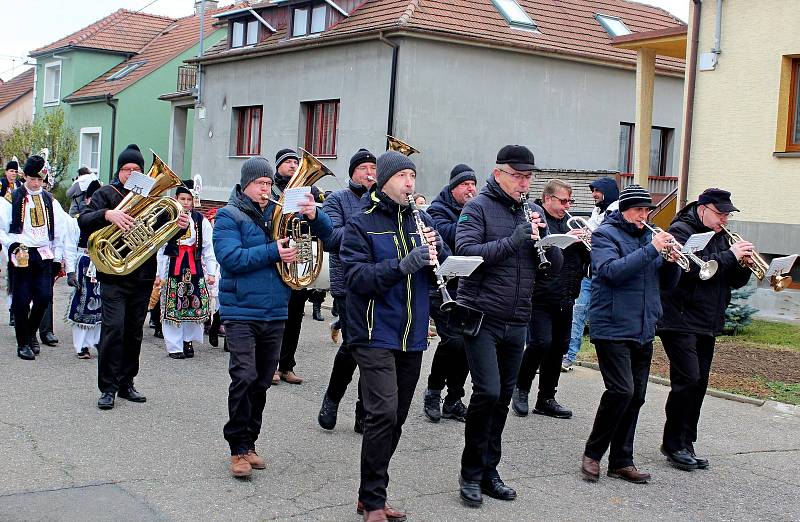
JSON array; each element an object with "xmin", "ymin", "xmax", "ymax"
[{"xmin": 658, "ymin": 202, "xmax": 751, "ymax": 336}]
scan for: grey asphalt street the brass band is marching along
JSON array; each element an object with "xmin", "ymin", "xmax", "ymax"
[{"xmin": 0, "ymin": 282, "xmax": 800, "ymax": 521}]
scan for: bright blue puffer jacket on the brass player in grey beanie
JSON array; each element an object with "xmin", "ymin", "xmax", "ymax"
[{"xmin": 214, "ymin": 185, "xmax": 332, "ymax": 321}]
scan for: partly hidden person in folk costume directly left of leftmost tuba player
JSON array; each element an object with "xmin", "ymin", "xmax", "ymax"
[{"xmin": 64, "ymin": 180, "xmax": 101, "ymax": 359}]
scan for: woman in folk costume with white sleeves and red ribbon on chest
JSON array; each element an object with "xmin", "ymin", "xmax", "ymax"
[{"xmin": 158, "ymin": 180, "xmax": 217, "ymax": 359}]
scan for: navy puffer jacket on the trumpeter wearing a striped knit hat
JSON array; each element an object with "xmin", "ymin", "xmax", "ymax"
[{"xmin": 589, "ymin": 211, "xmax": 681, "ymax": 344}]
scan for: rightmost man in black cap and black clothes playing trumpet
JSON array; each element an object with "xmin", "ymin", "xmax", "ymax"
[{"xmin": 657, "ymin": 188, "xmax": 753, "ymax": 471}]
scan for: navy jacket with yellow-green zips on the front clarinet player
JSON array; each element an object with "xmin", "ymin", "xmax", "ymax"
[{"xmin": 339, "ymin": 192, "xmax": 448, "ymax": 351}]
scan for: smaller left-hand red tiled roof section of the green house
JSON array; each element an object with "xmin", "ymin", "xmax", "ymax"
[{"xmin": 30, "ymin": 9, "xmax": 175, "ymax": 57}]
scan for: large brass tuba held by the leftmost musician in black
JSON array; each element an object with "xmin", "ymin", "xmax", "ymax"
[{"xmin": 86, "ymin": 149, "xmax": 183, "ymax": 275}]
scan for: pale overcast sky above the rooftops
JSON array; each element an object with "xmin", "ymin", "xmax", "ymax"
[{"xmin": 0, "ymin": 0, "xmax": 690, "ymax": 80}]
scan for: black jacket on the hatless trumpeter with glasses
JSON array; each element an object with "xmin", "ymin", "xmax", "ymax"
[{"xmin": 533, "ymin": 200, "xmax": 591, "ymax": 307}]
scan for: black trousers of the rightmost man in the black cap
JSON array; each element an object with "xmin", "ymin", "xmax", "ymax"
[{"xmin": 659, "ymin": 332, "xmax": 715, "ymax": 451}]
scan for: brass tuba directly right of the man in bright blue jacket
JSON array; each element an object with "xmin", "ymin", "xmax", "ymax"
[{"xmin": 272, "ymin": 148, "xmax": 333, "ymax": 290}]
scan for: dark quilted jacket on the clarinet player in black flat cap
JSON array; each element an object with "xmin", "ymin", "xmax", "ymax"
[{"xmin": 456, "ymin": 177, "xmax": 564, "ymax": 325}]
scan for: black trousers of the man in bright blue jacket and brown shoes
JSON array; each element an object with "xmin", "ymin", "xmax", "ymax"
[{"xmin": 222, "ymin": 314, "xmax": 284, "ymax": 455}]
